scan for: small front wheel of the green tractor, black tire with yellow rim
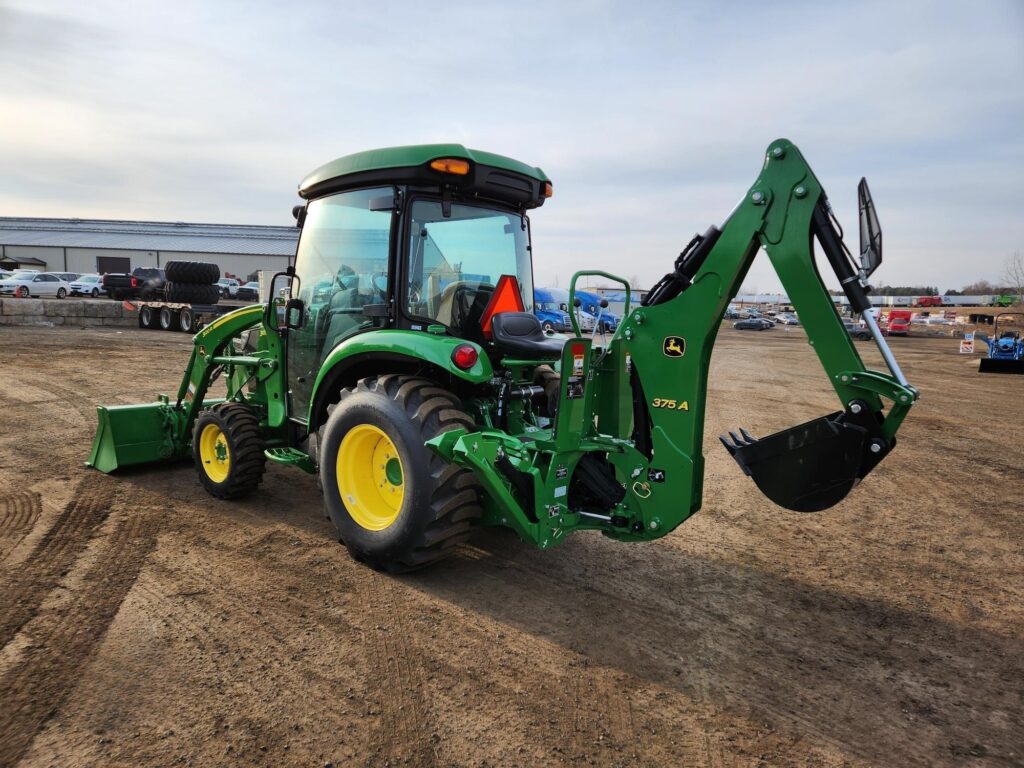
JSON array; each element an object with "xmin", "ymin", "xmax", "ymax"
[{"xmin": 193, "ymin": 402, "xmax": 266, "ymax": 499}]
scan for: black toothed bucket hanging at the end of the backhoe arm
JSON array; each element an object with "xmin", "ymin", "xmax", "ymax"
[{"xmin": 720, "ymin": 411, "xmax": 892, "ymax": 512}]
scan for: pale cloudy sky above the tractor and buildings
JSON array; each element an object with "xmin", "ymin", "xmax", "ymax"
[{"xmin": 0, "ymin": 0, "xmax": 1024, "ymax": 292}]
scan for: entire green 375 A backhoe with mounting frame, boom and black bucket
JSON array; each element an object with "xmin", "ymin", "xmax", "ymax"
[{"xmin": 429, "ymin": 139, "xmax": 918, "ymax": 547}]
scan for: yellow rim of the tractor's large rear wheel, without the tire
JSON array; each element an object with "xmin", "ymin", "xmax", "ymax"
[{"xmin": 337, "ymin": 424, "xmax": 406, "ymax": 530}]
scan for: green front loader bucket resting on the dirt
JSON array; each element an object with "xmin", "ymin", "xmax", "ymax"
[{"xmin": 86, "ymin": 402, "xmax": 182, "ymax": 472}]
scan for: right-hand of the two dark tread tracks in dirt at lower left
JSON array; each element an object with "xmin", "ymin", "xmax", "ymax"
[{"xmin": 0, "ymin": 511, "xmax": 160, "ymax": 766}]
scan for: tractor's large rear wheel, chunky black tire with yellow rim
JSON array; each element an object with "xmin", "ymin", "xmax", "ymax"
[{"xmin": 316, "ymin": 375, "xmax": 482, "ymax": 572}]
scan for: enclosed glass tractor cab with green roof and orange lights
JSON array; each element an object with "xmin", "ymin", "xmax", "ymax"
[{"xmin": 288, "ymin": 144, "xmax": 557, "ymax": 419}]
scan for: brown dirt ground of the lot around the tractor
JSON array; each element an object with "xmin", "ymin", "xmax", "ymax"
[{"xmin": 0, "ymin": 328, "xmax": 1024, "ymax": 767}]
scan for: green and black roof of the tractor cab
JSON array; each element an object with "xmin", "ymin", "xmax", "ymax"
[{"xmin": 299, "ymin": 144, "xmax": 550, "ymax": 208}]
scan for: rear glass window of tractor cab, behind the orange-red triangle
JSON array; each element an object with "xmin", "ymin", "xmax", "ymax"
[{"xmin": 403, "ymin": 200, "xmax": 534, "ymax": 338}]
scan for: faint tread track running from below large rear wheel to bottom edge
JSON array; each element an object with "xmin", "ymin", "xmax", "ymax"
[{"xmin": 354, "ymin": 571, "xmax": 439, "ymax": 766}]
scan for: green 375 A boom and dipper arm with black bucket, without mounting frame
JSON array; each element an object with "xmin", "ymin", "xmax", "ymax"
[{"xmin": 613, "ymin": 139, "xmax": 918, "ymax": 524}]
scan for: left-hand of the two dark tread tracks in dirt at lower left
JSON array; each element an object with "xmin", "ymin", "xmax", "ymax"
[{"xmin": 0, "ymin": 474, "xmax": 115, "ymax": 647}]
